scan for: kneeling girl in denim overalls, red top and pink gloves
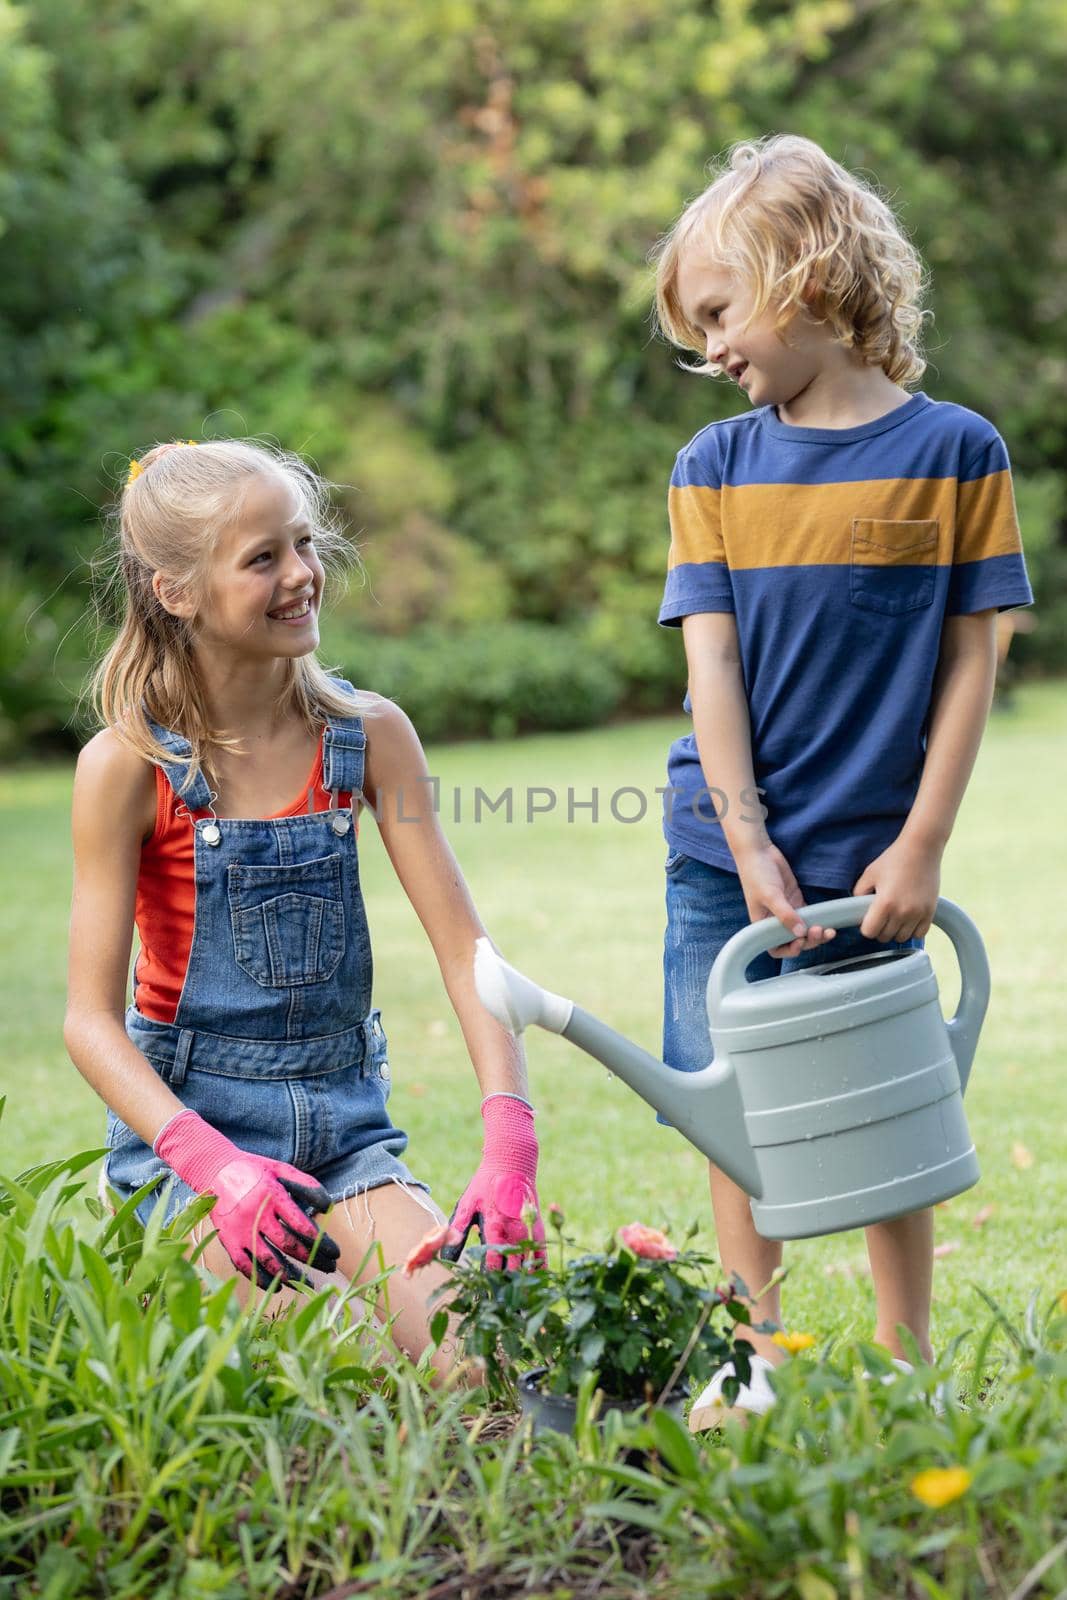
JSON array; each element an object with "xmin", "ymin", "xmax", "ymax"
[{"xmin": 64, "ymin": 440, "xmax": 544, "ymax": 1365}]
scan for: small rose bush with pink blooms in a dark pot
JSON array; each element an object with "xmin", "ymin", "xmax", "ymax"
[{"xmin": 405, "ymin": 1206, "xmax": 767, "ymax": 1432}]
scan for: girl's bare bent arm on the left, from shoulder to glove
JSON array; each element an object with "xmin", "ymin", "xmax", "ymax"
[{"xmin": 62, "ymin": 731, "xmax": 182, "ymax": 1144}]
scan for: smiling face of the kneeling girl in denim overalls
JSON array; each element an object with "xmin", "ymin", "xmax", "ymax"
[{"xmin": 155, "ymin": 474, "xmax": 325, "ymax": 659}]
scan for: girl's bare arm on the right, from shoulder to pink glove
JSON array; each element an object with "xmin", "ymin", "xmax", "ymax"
[{"xmin": 365, "ymin": 701, "xmax": 528, "ymax": 1098}]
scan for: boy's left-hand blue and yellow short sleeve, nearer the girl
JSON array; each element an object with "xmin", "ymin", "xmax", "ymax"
[{"xmin": 659, "ymin": 429, "xmax": 734, "ymax": 627}]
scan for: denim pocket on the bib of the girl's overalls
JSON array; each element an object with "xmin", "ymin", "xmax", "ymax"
[{"xmin": 227, "ymin": 856, "xmax": 344, "ymax": 989}]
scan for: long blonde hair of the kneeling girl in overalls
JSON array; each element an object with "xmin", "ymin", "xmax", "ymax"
[{"xmin": 86, "ymin": 438, "xmax": 370, "ymax": 792}]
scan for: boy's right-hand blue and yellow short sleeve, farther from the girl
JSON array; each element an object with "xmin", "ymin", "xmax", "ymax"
[{"xmin": 947, "ymin": 427, "xmax": 1033, "ymax": 616}]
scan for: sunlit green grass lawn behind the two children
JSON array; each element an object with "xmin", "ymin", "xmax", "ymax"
[{"xmin": 0, "ymin": 683, "xmax": 1067, "ymax": 1369}]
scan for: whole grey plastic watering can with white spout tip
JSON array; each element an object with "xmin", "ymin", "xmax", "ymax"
[{"xmin": 475, "ymin": 894, "xmax": 989, "ymax": 1238}]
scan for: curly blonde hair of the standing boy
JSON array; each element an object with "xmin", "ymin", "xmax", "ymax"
[{"xmin": 653, "ymin": 133, "xmax": 933, "ymax": 384}]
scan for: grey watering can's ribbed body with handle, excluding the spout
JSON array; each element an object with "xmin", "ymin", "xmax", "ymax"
[{"xmin": 707, "ymin": 896, "xmax": 989, "ymax": 1238}]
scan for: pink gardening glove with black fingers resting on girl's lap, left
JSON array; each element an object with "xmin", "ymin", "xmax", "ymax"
[{"xmin": 152, "ymin": 1110, "xmax": 341, "ymax": 1290}]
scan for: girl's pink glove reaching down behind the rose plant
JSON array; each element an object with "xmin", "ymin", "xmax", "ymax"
[{"xmin": 442, "ymin": 1094, "xmax": 545, "ymax": 1272}]
